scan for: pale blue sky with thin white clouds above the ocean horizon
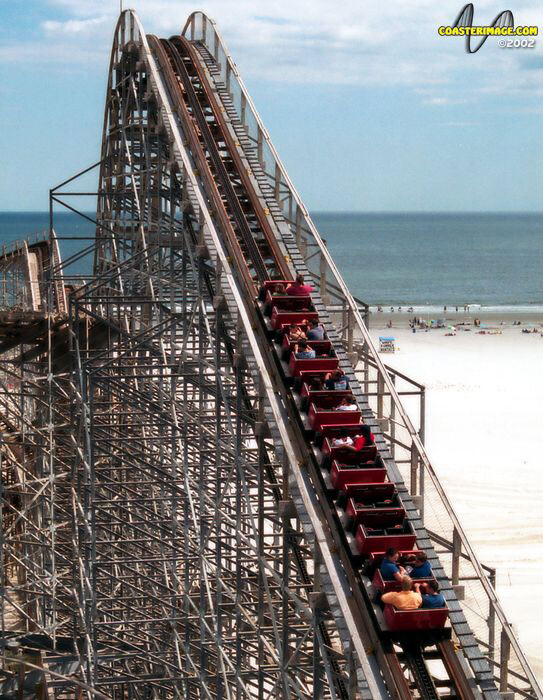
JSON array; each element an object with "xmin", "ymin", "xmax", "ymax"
[{"xmin": 0, "ymin": 0, "xmax": 543, "ymax": 211}]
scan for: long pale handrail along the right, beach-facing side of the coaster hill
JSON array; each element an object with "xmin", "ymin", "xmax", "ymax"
[{"xmin": 181, "ymin": 12, "xmax": 543, "ymax": 700}]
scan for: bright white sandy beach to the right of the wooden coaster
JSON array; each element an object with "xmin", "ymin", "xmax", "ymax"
[{"xmin": 370, "ymin": 313, "xmax": 543, "ymax": 681}]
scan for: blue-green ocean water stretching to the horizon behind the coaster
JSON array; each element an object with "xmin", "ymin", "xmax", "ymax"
[{"xmin": 0, "ymin": 212, "xmax": 543, "ymax": 311}]
